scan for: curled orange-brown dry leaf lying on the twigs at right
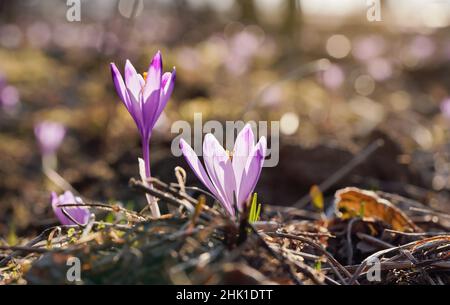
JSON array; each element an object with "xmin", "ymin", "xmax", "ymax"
[{"xmin": 335, "ymin": 187, "xmax": 422, "ymax": 232}]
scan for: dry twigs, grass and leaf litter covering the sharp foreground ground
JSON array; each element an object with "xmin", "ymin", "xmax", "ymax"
[{"xmin": 0, "ymin": 180, "xmax": 450, "ymax": 285}]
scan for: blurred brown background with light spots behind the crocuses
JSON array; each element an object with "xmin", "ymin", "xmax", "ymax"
[{"xmin": 0, "ymin": 0, "xmax": 450, "ymax": 238}]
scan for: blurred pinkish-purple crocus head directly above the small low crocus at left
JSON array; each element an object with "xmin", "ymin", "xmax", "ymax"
[{"xmin": 34, "ymin": 121, "xmax": 66, "ymax": 155}]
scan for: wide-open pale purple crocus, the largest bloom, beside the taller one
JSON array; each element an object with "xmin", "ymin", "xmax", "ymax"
[{"xmin": 180, "ymin": 124, "xmax": 267, "ymax": 217}]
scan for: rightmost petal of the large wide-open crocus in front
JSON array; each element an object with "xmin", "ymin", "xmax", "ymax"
[{"xmin": 238, "ymin": 137, "xmax": 267, "ymax": 209}]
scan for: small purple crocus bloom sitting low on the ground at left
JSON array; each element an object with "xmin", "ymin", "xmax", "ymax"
[{"xmin": 51, "ymin": 191, "xmax": 90, "ymax": 225}]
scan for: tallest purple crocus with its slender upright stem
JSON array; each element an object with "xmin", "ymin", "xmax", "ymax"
[{"xmin": 111, "ymin": 51, "xmax": 175, "ymax": 178}]
